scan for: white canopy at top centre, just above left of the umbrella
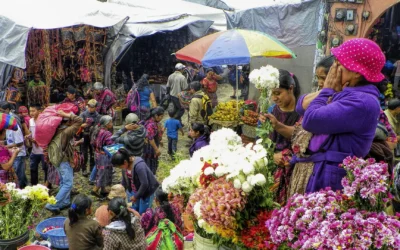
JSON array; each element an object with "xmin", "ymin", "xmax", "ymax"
[{"xmin": 108, "ymin": 0, "xmax": 226, "ymax": 30}]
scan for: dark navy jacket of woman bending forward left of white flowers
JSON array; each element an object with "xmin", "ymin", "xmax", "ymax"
[{"xmin": 122, "ymin": 157, "xmax": 160, "ymax": 200}]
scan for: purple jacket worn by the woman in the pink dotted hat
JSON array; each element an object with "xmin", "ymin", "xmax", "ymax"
[{"xmin": 296, "ymin": 84, "xmax": 380, "ymax": 193}]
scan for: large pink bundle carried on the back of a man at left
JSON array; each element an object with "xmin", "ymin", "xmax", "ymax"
[{"xmin": 35, "ymin": 103, "xmax": 79, "ymax": 148}]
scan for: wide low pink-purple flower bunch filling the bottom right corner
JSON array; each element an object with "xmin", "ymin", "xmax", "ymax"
[{"xmin": 266, "ymin": 189, "xmax": 400, "ymax": 249}]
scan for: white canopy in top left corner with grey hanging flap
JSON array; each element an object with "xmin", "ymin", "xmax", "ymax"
[{"xmin": 0, "ymin": 0, "xmax": 127, "ymax": 68}]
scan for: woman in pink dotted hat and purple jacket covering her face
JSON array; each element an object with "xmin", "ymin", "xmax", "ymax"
[{"xmin": 293, "ymin": 38, "xmax": 385, "ymax": 193}]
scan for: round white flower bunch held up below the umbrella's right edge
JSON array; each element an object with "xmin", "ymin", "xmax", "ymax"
[{"xmin": 249, "ymin": 65, "xmax": 279, "ymax": 91}]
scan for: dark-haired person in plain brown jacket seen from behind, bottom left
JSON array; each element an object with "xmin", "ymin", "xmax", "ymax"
[{"xmin": 64, "ymin": 194, "xmax": 103, "ymax": 250}]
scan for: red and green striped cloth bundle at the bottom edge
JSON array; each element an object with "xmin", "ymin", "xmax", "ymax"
[{"xmin": 146, "ymin": 219, "xmax": 184, "ymax": 250}]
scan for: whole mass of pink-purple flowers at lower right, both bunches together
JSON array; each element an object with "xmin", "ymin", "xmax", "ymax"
[{"xmin": 266, "ymin": 157, "xmax": 400, "ymax": 249}]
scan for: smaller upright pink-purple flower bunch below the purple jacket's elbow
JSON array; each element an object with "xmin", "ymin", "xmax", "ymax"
[{"xmin": 341, "ymin": 157, "xmax": 390, "ymax": 212}]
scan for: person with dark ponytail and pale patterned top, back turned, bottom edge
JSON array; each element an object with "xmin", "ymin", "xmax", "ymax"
[{"xmin": 104, "ymin": 198, "xmax": 146, "ymax": 250}]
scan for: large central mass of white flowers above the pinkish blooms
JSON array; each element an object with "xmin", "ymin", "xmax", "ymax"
[{"xmin": 162, "ymin": 128, "xmax": 268, "ymax": 195}]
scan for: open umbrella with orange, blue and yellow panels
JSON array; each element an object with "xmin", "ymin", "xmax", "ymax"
[{"xmin": 175, "ymin": 29, "xmax": 296, "ymax": 67}]
